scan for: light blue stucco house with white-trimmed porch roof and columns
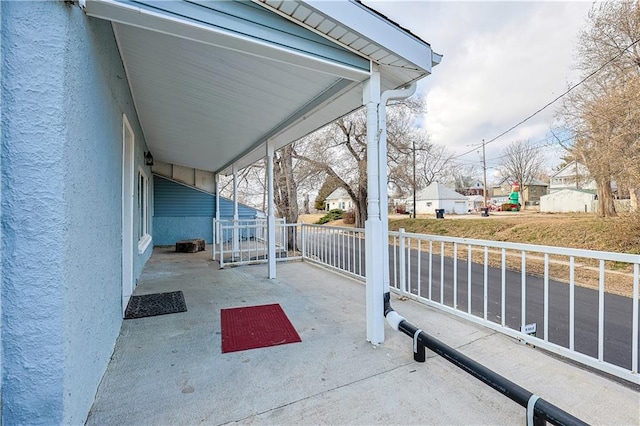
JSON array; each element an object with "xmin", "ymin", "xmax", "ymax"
[{"xmin": 0, "ymin": 0, "xmax": 440, "ymax": 425}]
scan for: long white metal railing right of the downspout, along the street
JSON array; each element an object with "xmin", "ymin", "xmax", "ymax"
[{"xmin": 389, "ymin": 229, "xmax": 640, "ymax": 384}]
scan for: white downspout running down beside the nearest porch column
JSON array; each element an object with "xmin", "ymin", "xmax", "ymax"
[{"xmin": 378, "ymin": 83, "xmax": 418, "ymax": 294}]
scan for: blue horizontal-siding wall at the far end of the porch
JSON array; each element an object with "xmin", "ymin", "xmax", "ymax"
[{"xmin": 153, "ymin": 176, "xmax": 259, "ymax": 246}]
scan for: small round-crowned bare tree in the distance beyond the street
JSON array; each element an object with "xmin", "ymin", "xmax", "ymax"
[{"xmin": 499, "ymin": 140, "xmax": 545, "ymax": 208}]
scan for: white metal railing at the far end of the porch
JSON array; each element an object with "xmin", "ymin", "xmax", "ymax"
[{"xmin": 212, "ymin": 218, "xmax": 302, "ymax": 268}]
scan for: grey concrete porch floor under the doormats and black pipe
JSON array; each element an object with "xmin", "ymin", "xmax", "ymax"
[{"xmin": 87, "ymin": 248, "xmax": 640, "ymax": 425}]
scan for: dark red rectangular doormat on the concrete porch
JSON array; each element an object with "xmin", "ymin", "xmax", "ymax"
[{"xmin": 220, "ymin": 303, "xmax": 302, "ymax": 353}]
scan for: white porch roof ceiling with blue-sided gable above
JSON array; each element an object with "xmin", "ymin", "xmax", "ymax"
[{"xmin": 85, "ymin": 0, "xmax": 439, "ymax": 173}]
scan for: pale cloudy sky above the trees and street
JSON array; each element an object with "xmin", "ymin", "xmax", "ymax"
[{"xmin": 364, "ymin": 0, "xmax": 592, "ymax": 181}]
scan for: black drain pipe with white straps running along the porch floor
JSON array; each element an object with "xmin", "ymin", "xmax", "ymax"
[{"xmin": 384, "ymin": 293, "xmax": 587, "ymax": 425}]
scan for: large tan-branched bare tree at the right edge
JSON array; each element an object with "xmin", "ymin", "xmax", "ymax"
[{"xmin": 561, "ymin": 1, "xmax": 640, "ymax": 217}]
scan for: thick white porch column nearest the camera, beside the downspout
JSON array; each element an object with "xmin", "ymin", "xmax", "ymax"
[{"xmin": 362, "ymin": 64, "xmax": 387, "ymax": 345}]
